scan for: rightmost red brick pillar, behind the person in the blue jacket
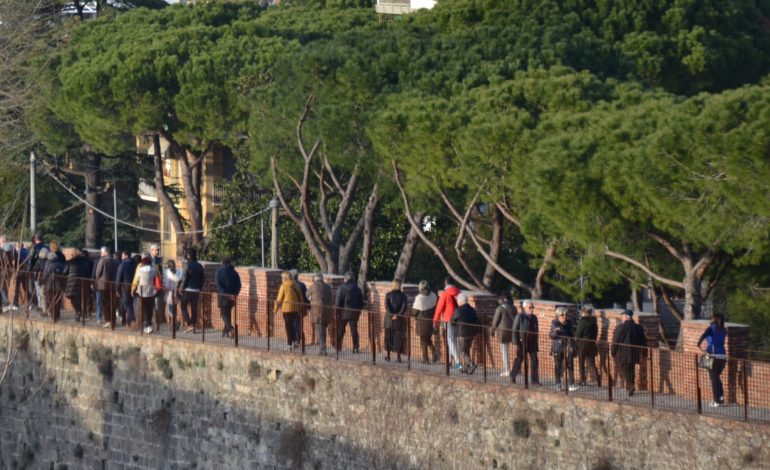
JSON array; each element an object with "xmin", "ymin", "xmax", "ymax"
[{"xmin": 681, "ymin": 320, "xmax": 749, "ymax": 403}]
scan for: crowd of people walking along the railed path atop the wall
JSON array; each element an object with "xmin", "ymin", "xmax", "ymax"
[{"xmin": 0, "ymin": 233, "xmax": 727, "ymax": 406}]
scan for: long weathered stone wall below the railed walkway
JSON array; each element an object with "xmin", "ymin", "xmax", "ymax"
[{"xmin": 0, "ymin": 316, "xmax": 770, "ymax": 469}]
